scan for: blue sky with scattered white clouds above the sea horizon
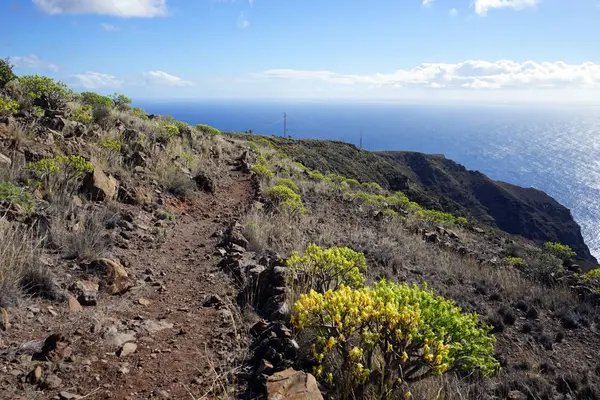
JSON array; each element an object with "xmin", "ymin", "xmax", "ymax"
[{"xmin": 0, "ymin": 0, "xmax": 600, "ymax": 104}]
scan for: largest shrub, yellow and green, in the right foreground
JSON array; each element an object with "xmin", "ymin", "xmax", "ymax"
[{"xmin": 292, "ymin": 281, "xmax": 499, "ymax": 399}]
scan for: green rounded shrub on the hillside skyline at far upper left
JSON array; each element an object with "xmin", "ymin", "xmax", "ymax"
[{"xmin": 19, "ymin": 75, "xmax": 75, "ymax": 110}]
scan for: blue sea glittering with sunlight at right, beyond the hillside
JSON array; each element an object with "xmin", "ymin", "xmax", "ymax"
[{"xmin": 139, "ymin": 100, "xmax": 600, "ymax": 257}]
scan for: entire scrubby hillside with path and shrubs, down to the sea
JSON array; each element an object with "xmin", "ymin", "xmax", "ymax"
[{"xmin": 0, "ymin": 65, "xmax": 600, "ymax": 400}]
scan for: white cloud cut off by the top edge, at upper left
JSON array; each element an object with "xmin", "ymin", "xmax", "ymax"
[{"xmin": 33, "ymin": 0, "xmax": 167, "ymax": 18}]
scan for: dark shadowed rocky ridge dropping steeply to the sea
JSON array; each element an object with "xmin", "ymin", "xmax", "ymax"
[{"xmin": 247, "ymin": 139, "xmax": 596, "ymax": 263}]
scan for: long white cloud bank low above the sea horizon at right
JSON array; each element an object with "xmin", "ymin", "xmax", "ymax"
[{"xmin": 257, "ymin": 60, "xmax": 600, "ymax": 89}]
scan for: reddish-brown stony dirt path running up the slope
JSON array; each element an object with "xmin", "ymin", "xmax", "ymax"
[{"xmin": 0, "ymin": 163, "xmax": 254, "ymax": 399}]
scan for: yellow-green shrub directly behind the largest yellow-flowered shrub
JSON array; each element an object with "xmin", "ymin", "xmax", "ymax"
[{"xmin": 287, "ymin": 243, "xmax": 367, "ymax": 293}]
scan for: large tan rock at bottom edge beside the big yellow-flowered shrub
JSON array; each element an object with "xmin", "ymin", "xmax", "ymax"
[{"xmin": 267, "ymin": 368, "xmax": 323, "ymax": 400}]
